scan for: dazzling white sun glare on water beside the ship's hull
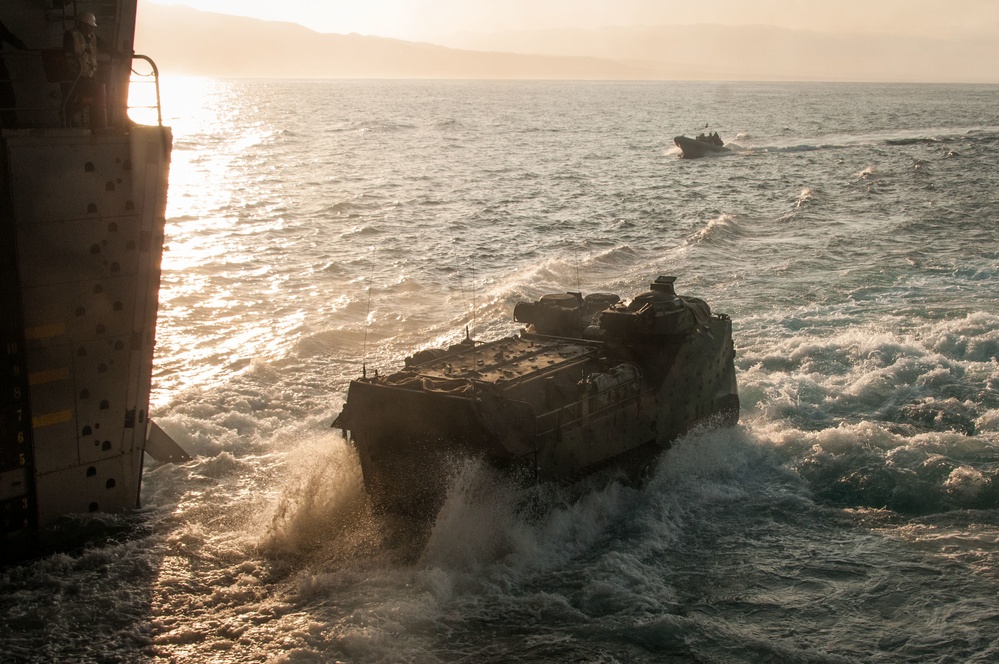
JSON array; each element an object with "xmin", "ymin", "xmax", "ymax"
[{"xmin": 136, "ymin": 75, "xmax": 300, "ymax": 401}]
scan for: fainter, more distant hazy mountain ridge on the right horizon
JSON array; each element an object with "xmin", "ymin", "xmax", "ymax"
[{"xmin": 439, "ymin": 24, "xmax": 999, "ymax": 83}]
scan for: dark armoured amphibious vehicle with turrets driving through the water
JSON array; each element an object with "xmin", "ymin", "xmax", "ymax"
[{"xmin": 333, "ymin": 276, "xmax": 739, "ymax": 518}]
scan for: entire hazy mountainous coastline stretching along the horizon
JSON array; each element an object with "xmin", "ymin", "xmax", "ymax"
[{"xmin": 136, "ymin": 3, "xmax": 999, "ymax": 84}]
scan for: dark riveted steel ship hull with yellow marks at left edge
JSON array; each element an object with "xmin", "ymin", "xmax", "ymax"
[{"xmin": 0, "ymin": 2, "xmax": 172, "ymax": 560}]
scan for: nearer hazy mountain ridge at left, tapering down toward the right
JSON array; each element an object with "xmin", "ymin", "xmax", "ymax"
[{"xmin": 135, "ymin": 4, "xmax": 657, "ymax": 79}]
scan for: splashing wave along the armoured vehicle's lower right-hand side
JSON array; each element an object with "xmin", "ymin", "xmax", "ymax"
[{"xmin": 420, "ymin": 427, "xmax": 772, "ymax": 577}]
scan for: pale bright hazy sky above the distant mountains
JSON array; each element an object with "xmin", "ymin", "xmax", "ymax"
[{"xmin": 148, "ymin": 0, "xmax": 999, "ymax": 40}]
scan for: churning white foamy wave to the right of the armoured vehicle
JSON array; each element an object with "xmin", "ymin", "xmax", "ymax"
[{"xmin": 737, "ymin": 312, "xmax": 999, "ymax": 514}]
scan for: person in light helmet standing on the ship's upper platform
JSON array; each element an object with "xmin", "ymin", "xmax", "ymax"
[{"xmin": 62, "ymin": 12, "xmax": 121, "ymax": 129}]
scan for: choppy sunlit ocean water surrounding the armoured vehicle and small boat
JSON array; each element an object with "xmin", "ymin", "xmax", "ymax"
[{"xmin": 0, "ymin": 80, "xmax": 999, "ymax": 664}]
